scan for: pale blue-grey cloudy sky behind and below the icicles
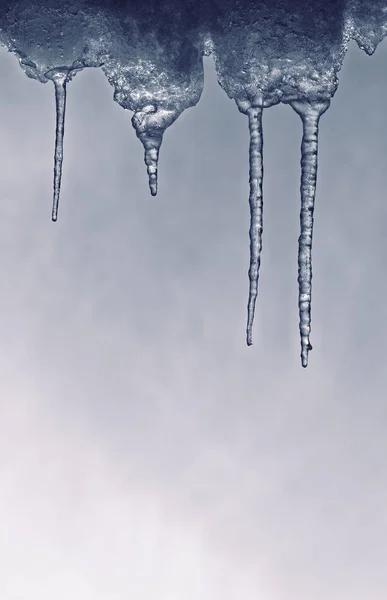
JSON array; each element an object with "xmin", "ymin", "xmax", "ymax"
[{"xmin": 0, "ymin": 37, "xmax": 387, "ymax": 600}]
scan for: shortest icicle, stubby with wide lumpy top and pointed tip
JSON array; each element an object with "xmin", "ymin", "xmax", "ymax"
[{"xmin": 132, "ymin": 104, "xmax": 179, "ymax": 196}]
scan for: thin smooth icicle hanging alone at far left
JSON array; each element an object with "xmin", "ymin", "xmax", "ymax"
[{"xmin": 52, "ymin": 71, "xmax": 68, "ymax": 221}]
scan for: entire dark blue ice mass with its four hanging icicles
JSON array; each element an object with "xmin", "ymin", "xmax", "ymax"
[{"xmin": 0, "ymin": 0, "xmax": 387, "ymax": 367}]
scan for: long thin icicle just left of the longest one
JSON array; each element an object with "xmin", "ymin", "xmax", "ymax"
[{"xmin": 246, "ymin": 107, "xmax": 263, "ymax": 346}]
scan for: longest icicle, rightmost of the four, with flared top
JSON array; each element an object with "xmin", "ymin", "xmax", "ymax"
[{"xmin": 290, "ymin": 100, "xmax": 330, "ymax": 367}]
